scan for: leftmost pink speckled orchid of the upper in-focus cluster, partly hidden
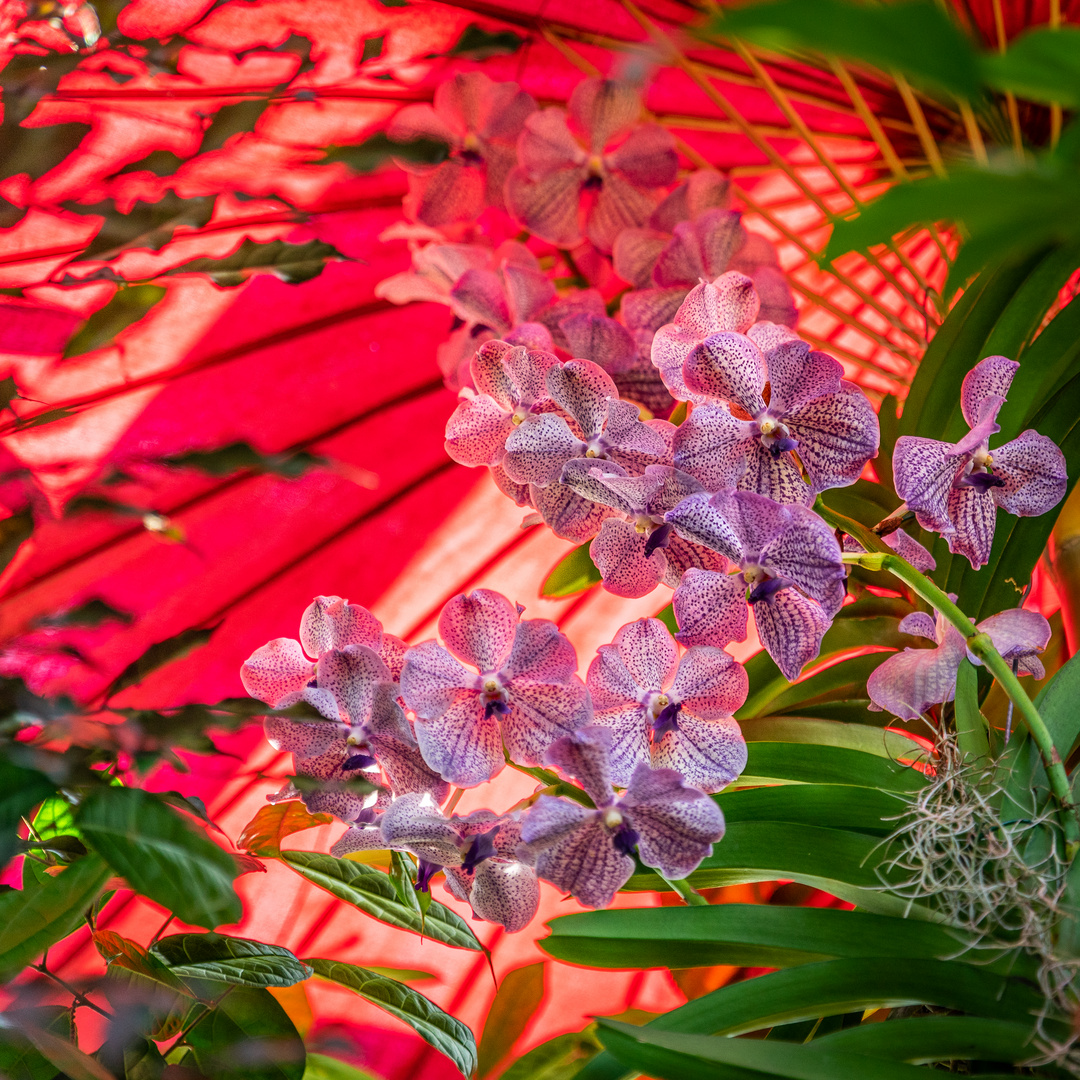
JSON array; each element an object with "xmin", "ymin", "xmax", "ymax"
[{"xmin": 446, "ymin": 340, "xmax": 558, "ymax": 465}]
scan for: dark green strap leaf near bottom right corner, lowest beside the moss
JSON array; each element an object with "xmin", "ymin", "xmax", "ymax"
[{"xmin": 809, "ymin": 1016, "xmax": 1035, "ymax": 1065}]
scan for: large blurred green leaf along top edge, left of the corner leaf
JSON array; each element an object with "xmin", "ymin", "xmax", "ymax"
[{"xmin": 710, "ymin": 0, "xmax": 980, "ymax": 105}]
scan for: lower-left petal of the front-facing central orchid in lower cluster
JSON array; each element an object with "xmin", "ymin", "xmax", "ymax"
[{"xmin": 406, "ymin": 690, "xmax": 507, "ymax": 787}]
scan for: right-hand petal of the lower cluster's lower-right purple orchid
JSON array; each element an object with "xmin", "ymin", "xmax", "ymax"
[{"xmin": 620, "ymin": 765, "xmax": 724, "ymax": 879}]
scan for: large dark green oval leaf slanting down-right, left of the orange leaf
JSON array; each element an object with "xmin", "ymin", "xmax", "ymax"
[{"xmin": 77, "ymin": 787, "xmax": 242, "ymax": 929}]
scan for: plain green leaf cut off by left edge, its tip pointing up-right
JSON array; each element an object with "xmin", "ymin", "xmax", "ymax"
[{"xmin": 0, "ymin": 855, "xmax": 109, "ymax": 982}]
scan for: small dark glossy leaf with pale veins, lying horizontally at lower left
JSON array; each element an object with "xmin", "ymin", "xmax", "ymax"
[{"xmin": 150, "ymin": 934, "xmax": 311, "ymax": 986}]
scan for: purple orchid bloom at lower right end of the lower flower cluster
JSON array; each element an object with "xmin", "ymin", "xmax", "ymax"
[{"xmin": 518, "ymin": 727, "xmax": 724, "ymax": 907}]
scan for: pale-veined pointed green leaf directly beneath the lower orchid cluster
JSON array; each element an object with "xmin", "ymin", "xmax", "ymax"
[{"xmin": 281, "ymin": 851, "xmax": 483, "ymax": 953}]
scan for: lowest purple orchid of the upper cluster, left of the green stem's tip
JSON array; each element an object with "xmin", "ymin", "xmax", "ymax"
[{"xmin": 666, "ymin": 490, "xmax": 845, "ymax": 681}]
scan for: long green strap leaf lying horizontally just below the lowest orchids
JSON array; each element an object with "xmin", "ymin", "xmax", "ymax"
[{"xmin": 539, "ymin": 904, "xmax": 1034, "ymax": 974}]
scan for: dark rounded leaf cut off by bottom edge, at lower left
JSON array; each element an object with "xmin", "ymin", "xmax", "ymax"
[{"xmin": 185, "ymin": 986, "xmax": 305, "ymax": 1080}]
